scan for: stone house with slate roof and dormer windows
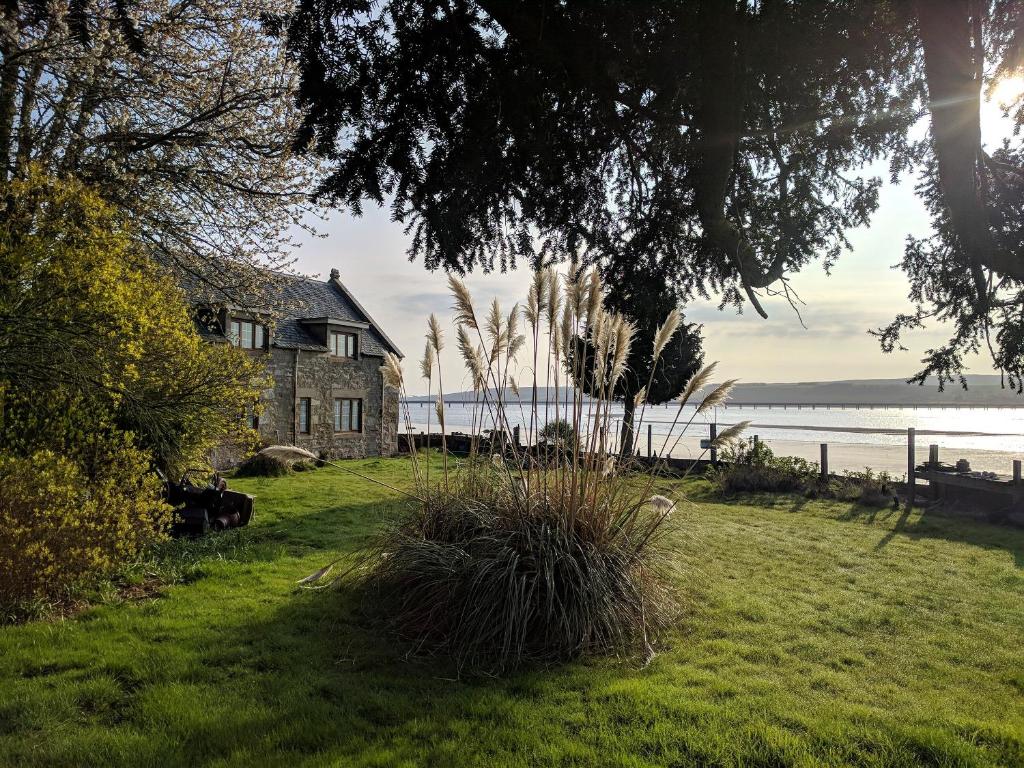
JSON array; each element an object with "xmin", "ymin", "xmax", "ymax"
[{"xmin": 193, "ymin": 269, "xmax": 401, "ymax": 458}]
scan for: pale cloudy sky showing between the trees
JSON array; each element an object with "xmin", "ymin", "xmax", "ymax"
[{"xmin": 284, "ymin": 91, "xmax": 1008, "ymax": 393}]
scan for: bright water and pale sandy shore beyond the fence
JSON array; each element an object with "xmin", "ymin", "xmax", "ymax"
[{"xmin": 410, "ymin": 402, "xmax": 1024, "ymax": 474}]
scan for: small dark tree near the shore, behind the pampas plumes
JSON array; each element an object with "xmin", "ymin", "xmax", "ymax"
[{"xmin": 566, "ymin": 262, "xmax": 703, "ymax": 456}]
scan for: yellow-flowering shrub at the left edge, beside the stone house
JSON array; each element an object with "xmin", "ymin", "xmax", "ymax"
[{"xmin": 0, "ymin": 169, "xmax": 265, "ymax": 621}]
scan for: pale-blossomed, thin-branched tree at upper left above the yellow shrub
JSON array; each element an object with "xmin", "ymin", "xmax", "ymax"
[{"xmin": 0, "ymin": 0, "xmax": 314, "ymax": 295}]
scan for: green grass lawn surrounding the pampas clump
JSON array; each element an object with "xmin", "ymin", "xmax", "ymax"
[{"xmin": 0, "ymin": 460, "xmax": 1024, "ymax": 768}]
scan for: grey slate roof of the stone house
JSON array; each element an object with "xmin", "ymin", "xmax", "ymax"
[{"xmin": 184, "ymin": 272, "xmax": 401, "ymax": 357}]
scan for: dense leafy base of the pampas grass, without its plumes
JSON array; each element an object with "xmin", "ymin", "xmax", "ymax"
[{"xmin": 369, "ymin": 463, "xmax": 674, "ymax": 672}]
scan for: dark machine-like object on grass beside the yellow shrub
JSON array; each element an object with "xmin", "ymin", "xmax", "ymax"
[{"xmin": 158, "ymin": 469, "xmax": 254, "ymax": 537}]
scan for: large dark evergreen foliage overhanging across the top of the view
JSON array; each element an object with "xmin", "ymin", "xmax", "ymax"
[{"xmin": 289, "ymin": 0, "xmax": 1024, "ymax": 391}]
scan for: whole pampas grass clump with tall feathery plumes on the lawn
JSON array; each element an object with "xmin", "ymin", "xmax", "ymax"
[{"xmin": 302, "ymin": 263, "xmax": 739, "ymax": 672}]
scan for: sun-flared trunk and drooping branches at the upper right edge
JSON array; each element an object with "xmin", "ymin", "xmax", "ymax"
[{"xmin": 874, "ymin": 0, "xmax": 1024, "ymax": 392}]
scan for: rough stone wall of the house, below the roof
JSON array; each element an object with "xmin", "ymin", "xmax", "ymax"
[{"xmin": 259, "ymin": 347, "xmax": 398, "ymax": 458}]
